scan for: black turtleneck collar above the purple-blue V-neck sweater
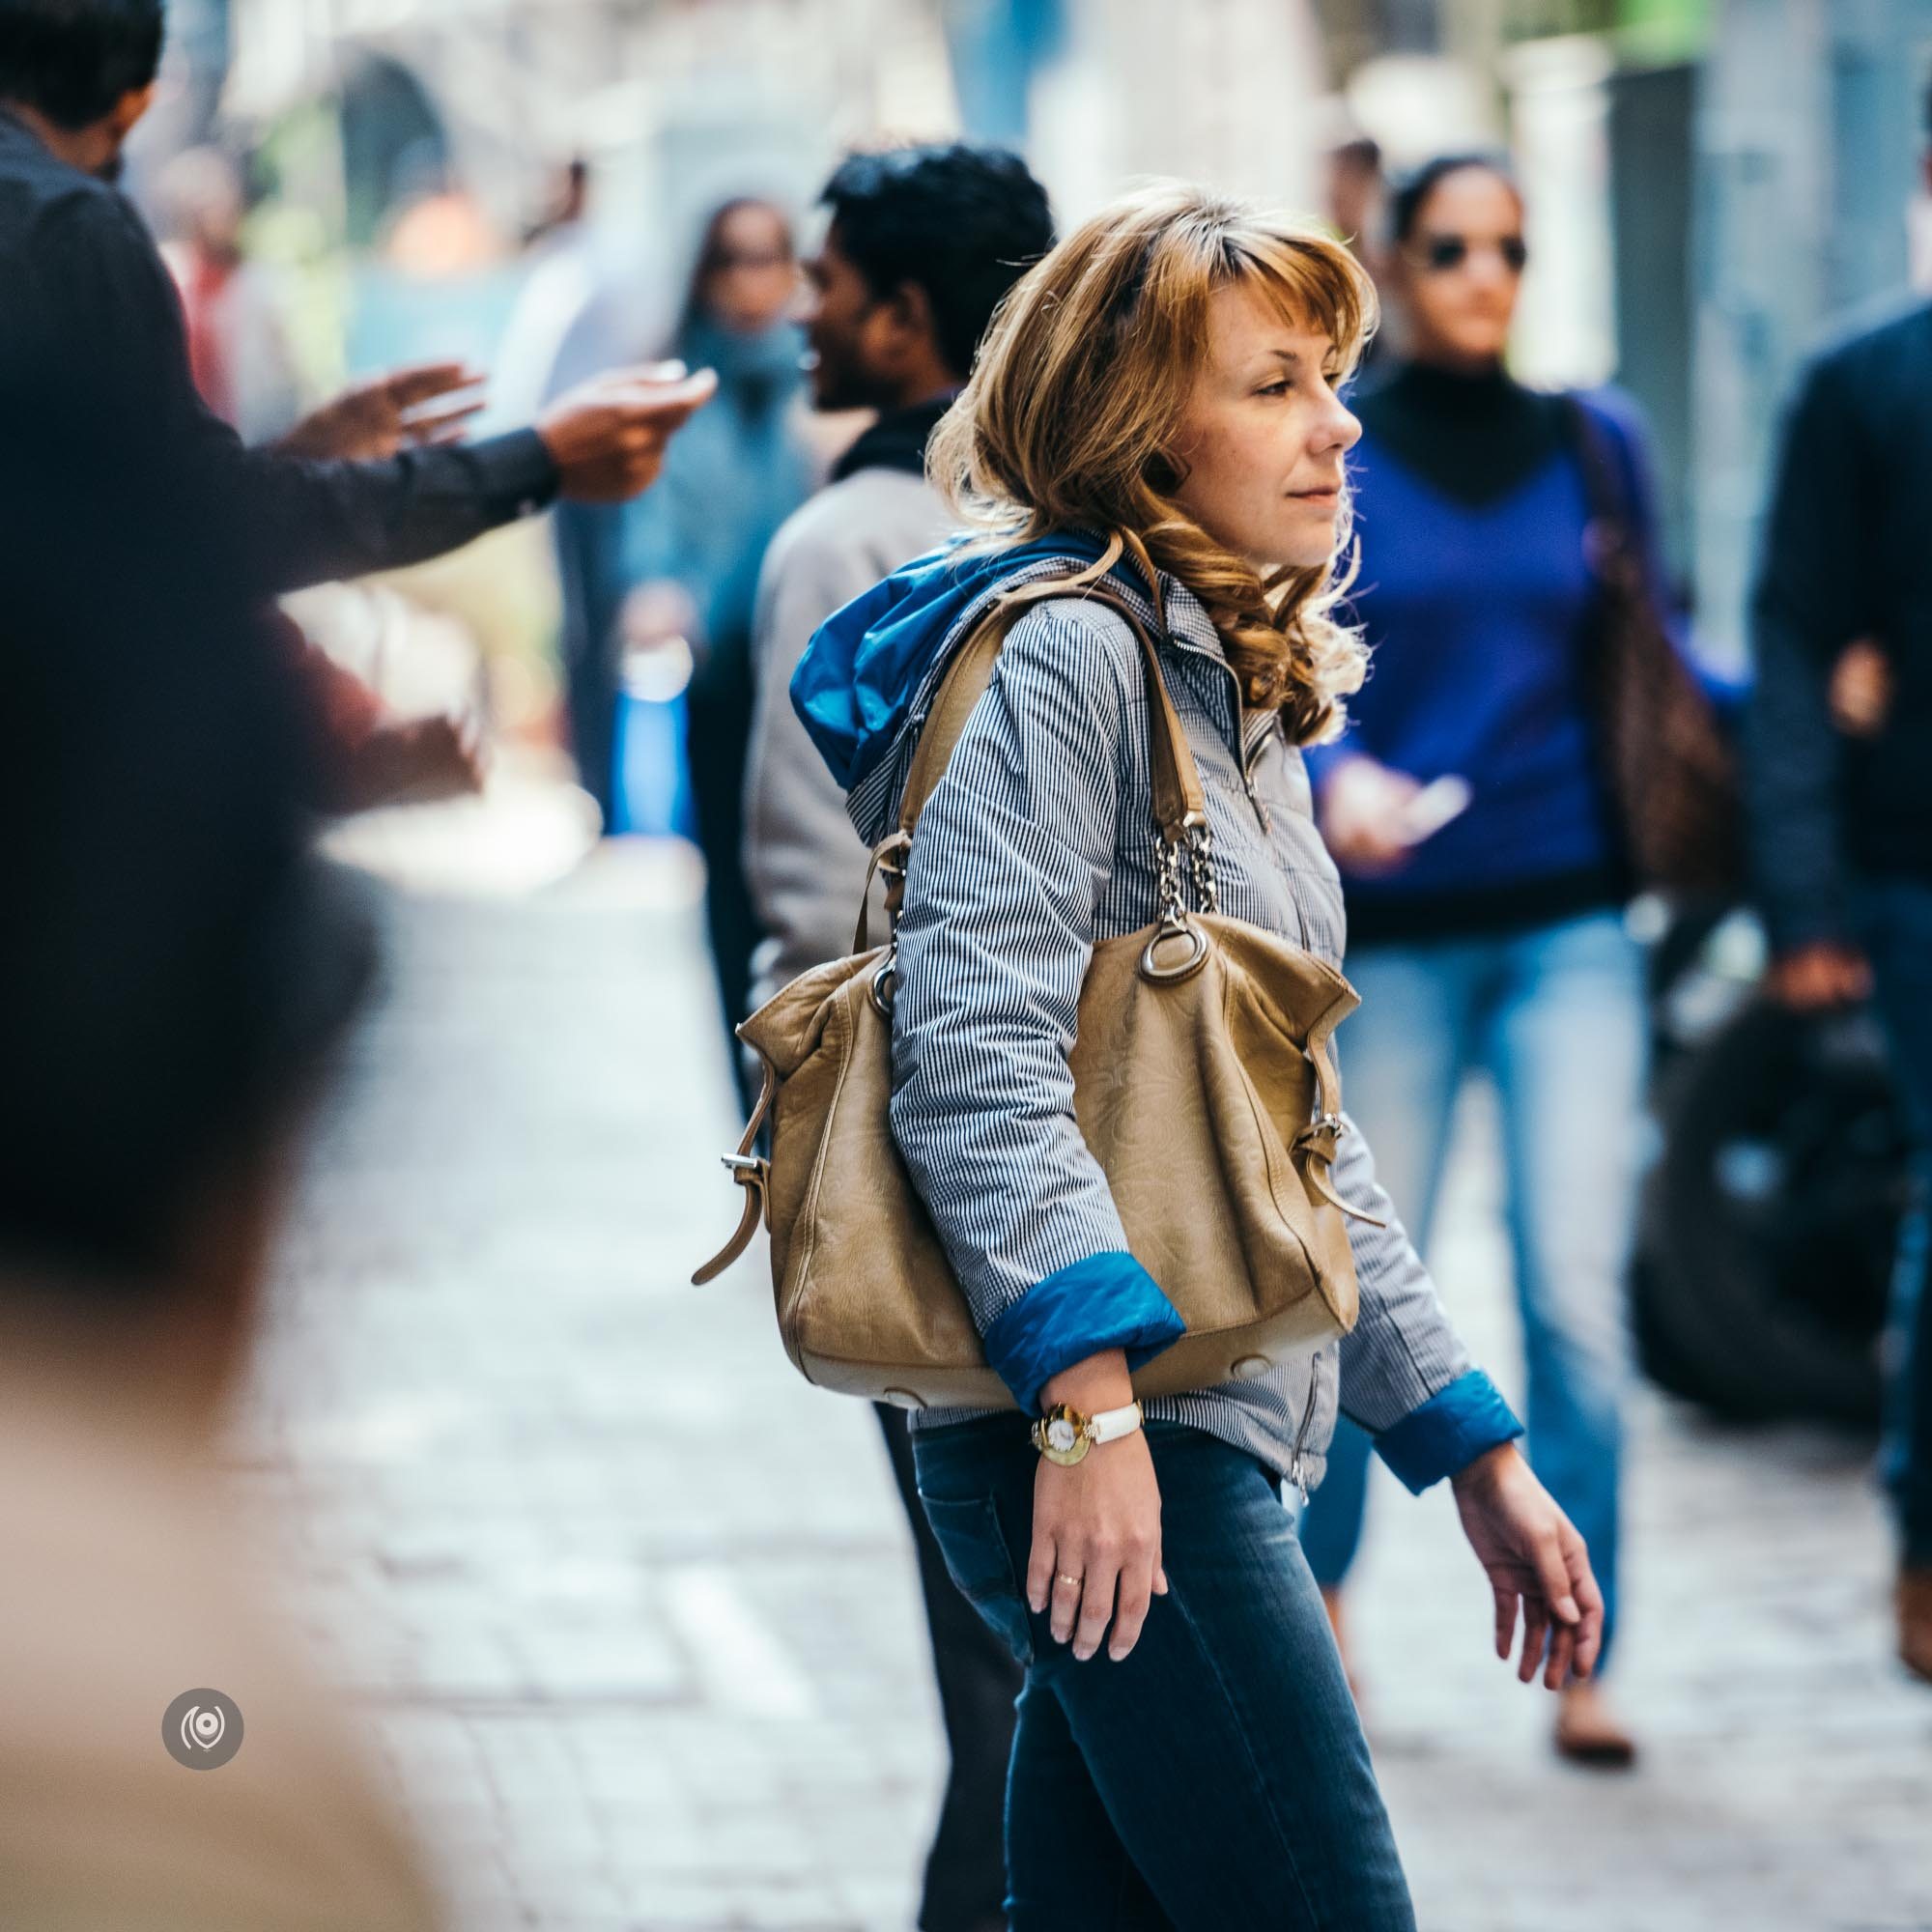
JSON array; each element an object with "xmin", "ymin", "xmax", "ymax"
[{"xmin": 1350, "ymin": 361, "xmax": 1567, "ymax": 506}]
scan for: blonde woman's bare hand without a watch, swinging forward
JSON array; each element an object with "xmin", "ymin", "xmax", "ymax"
[{"xmin": 1451, "ymin": 1443, "xmax": 1604, "ymax": 1690}]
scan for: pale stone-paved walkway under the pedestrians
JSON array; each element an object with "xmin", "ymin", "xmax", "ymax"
[{"xmin": 234, "ymin": 850, "xmax": 1932, "ymax": 1932}]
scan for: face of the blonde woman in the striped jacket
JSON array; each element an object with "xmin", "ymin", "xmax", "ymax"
[{"xmin": 1173, "ymin": 282, "xmax": 1362, "ymax": 574}]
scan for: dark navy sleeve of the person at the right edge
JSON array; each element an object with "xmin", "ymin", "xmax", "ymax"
[{"xmin": 1745, "ymin": 359, "xmax": 1872, "ymax": 951}]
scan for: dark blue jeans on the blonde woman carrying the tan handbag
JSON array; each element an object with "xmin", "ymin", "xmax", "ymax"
[{"xmin": 912, "ymin": 1414, "xmax": 1416, "ymax": 1932}]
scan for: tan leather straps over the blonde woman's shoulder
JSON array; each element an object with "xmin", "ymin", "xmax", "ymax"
[{"xmin": 852, "ymin": 533, "xmax": 1208, "ymax": 952}]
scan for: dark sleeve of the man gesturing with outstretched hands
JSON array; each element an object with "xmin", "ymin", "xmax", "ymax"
[{"xmin": 35, "ymin": 195, "xmax": 558, "ymax": 591}]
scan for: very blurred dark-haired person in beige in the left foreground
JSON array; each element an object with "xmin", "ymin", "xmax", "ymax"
[{"xmin": 0, "ymin": 309, "xmax": 440, "ymax": 1932}]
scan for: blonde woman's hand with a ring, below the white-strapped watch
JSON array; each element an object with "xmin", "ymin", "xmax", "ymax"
[{"xmin": 1026, "ymin": 1350, "xmax": 1167, "ymax": 1663}]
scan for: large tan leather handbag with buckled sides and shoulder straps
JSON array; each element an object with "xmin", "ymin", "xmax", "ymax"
[{"xmin": 694, "ymin": 549, "xmax": 1368, "ymax": 1408}]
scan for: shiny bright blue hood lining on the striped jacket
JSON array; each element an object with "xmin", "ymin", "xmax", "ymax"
[{"xmin": 792, "ymin": 531, "xmax": 1119, "ymax": 792}]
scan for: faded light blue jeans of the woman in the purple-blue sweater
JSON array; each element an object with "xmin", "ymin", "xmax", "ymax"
[{"xmin": 1300, "ymin": 912, "xmax": 1646, "ymax": 1658}]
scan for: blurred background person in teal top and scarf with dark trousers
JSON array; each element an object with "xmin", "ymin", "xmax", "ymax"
[{"xmin": 618, "ymin": 197, "xmax": 811, "ymax": 1068}]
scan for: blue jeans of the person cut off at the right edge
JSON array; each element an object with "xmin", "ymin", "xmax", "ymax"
[{"xmin": 1859, "ymin": 879, "xmax": 1932, "ymax": 1569}]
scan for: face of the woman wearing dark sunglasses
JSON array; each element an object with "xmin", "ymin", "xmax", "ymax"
[{"xmin": 1397, "ymin": 168, "xmax": 1526, "ymax": 363}]
